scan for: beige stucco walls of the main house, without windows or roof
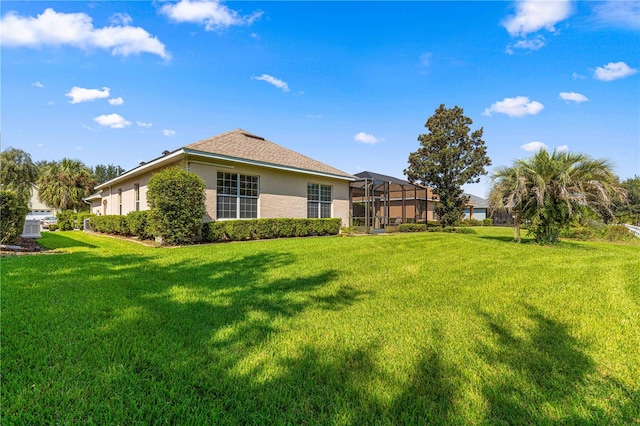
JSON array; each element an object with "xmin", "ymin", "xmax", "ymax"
[{"xmin": 92, "ymin": 156, "xmax": 349, "ymax": 226}]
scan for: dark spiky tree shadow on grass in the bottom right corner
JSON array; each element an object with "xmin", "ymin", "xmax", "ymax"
[{"xmin": 478, "ymin": 305, "xmax": 640, "ymax": 424}]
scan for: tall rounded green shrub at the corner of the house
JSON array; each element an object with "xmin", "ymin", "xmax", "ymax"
[{"xmin": 147, "ymin": 167, "xmax": 205, "ymax": 245}]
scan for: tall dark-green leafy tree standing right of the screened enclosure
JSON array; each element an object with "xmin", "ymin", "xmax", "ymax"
[{"xmin": 404, "ymin": 104, "xmax": 491, "ymax": 226}]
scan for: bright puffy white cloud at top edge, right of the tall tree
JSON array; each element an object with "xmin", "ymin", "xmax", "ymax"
[{"xmin": 502, "ymin": 0, "xmax": 573, "ymax": 37}]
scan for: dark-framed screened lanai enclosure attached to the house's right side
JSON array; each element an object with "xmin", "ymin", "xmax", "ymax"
[{"xmin": 351, "ymin": 172, "xmax": 437, "ymax": 233}]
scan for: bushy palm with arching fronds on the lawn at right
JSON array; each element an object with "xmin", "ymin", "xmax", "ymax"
[{"xmin": 489, "ymin": 150, "xmax": 625, "ymax": 244}]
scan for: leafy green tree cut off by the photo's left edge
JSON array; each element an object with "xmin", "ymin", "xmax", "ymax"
[{"xmin": 0, "ymin": 147, "xmax": 38, "ymax": 206}]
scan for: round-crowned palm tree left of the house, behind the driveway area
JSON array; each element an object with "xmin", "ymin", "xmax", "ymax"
[{"xmin": 38, "ymin": 158, "xmax": 96, "ymax": 210}]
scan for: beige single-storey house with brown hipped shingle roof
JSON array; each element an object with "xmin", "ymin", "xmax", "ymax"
[{"xmin": 85, "ymin": 129, "xmax": 356, "ymax": 226}]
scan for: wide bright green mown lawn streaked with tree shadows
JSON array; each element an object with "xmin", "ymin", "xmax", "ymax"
[{"xmin": 1, "ymin": 228, "xmax": 640, "ymax": 425}]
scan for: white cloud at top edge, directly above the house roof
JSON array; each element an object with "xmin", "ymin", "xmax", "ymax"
[{"xmin": 160, "ymin": 0, "xmax": 262, "ymax": 31}]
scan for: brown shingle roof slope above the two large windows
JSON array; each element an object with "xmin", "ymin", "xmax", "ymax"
[{"xmin": 184, "ymin": 129, "xmax": 353, "ymax": 178}]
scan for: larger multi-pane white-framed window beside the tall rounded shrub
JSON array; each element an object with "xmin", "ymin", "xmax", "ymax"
[{"xmin": 216, "ymin": 172, "xmax": 259, "ymax": 219}]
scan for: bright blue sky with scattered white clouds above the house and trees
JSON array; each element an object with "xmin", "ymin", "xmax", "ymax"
[{"xmin": 0, "ymin": 0, "xmax": 640, "ymax": 196}]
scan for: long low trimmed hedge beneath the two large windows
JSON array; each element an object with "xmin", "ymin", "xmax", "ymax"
[{"xmin": 202, "ymin": 218, "xmax": 342, "ymax": 242}]
